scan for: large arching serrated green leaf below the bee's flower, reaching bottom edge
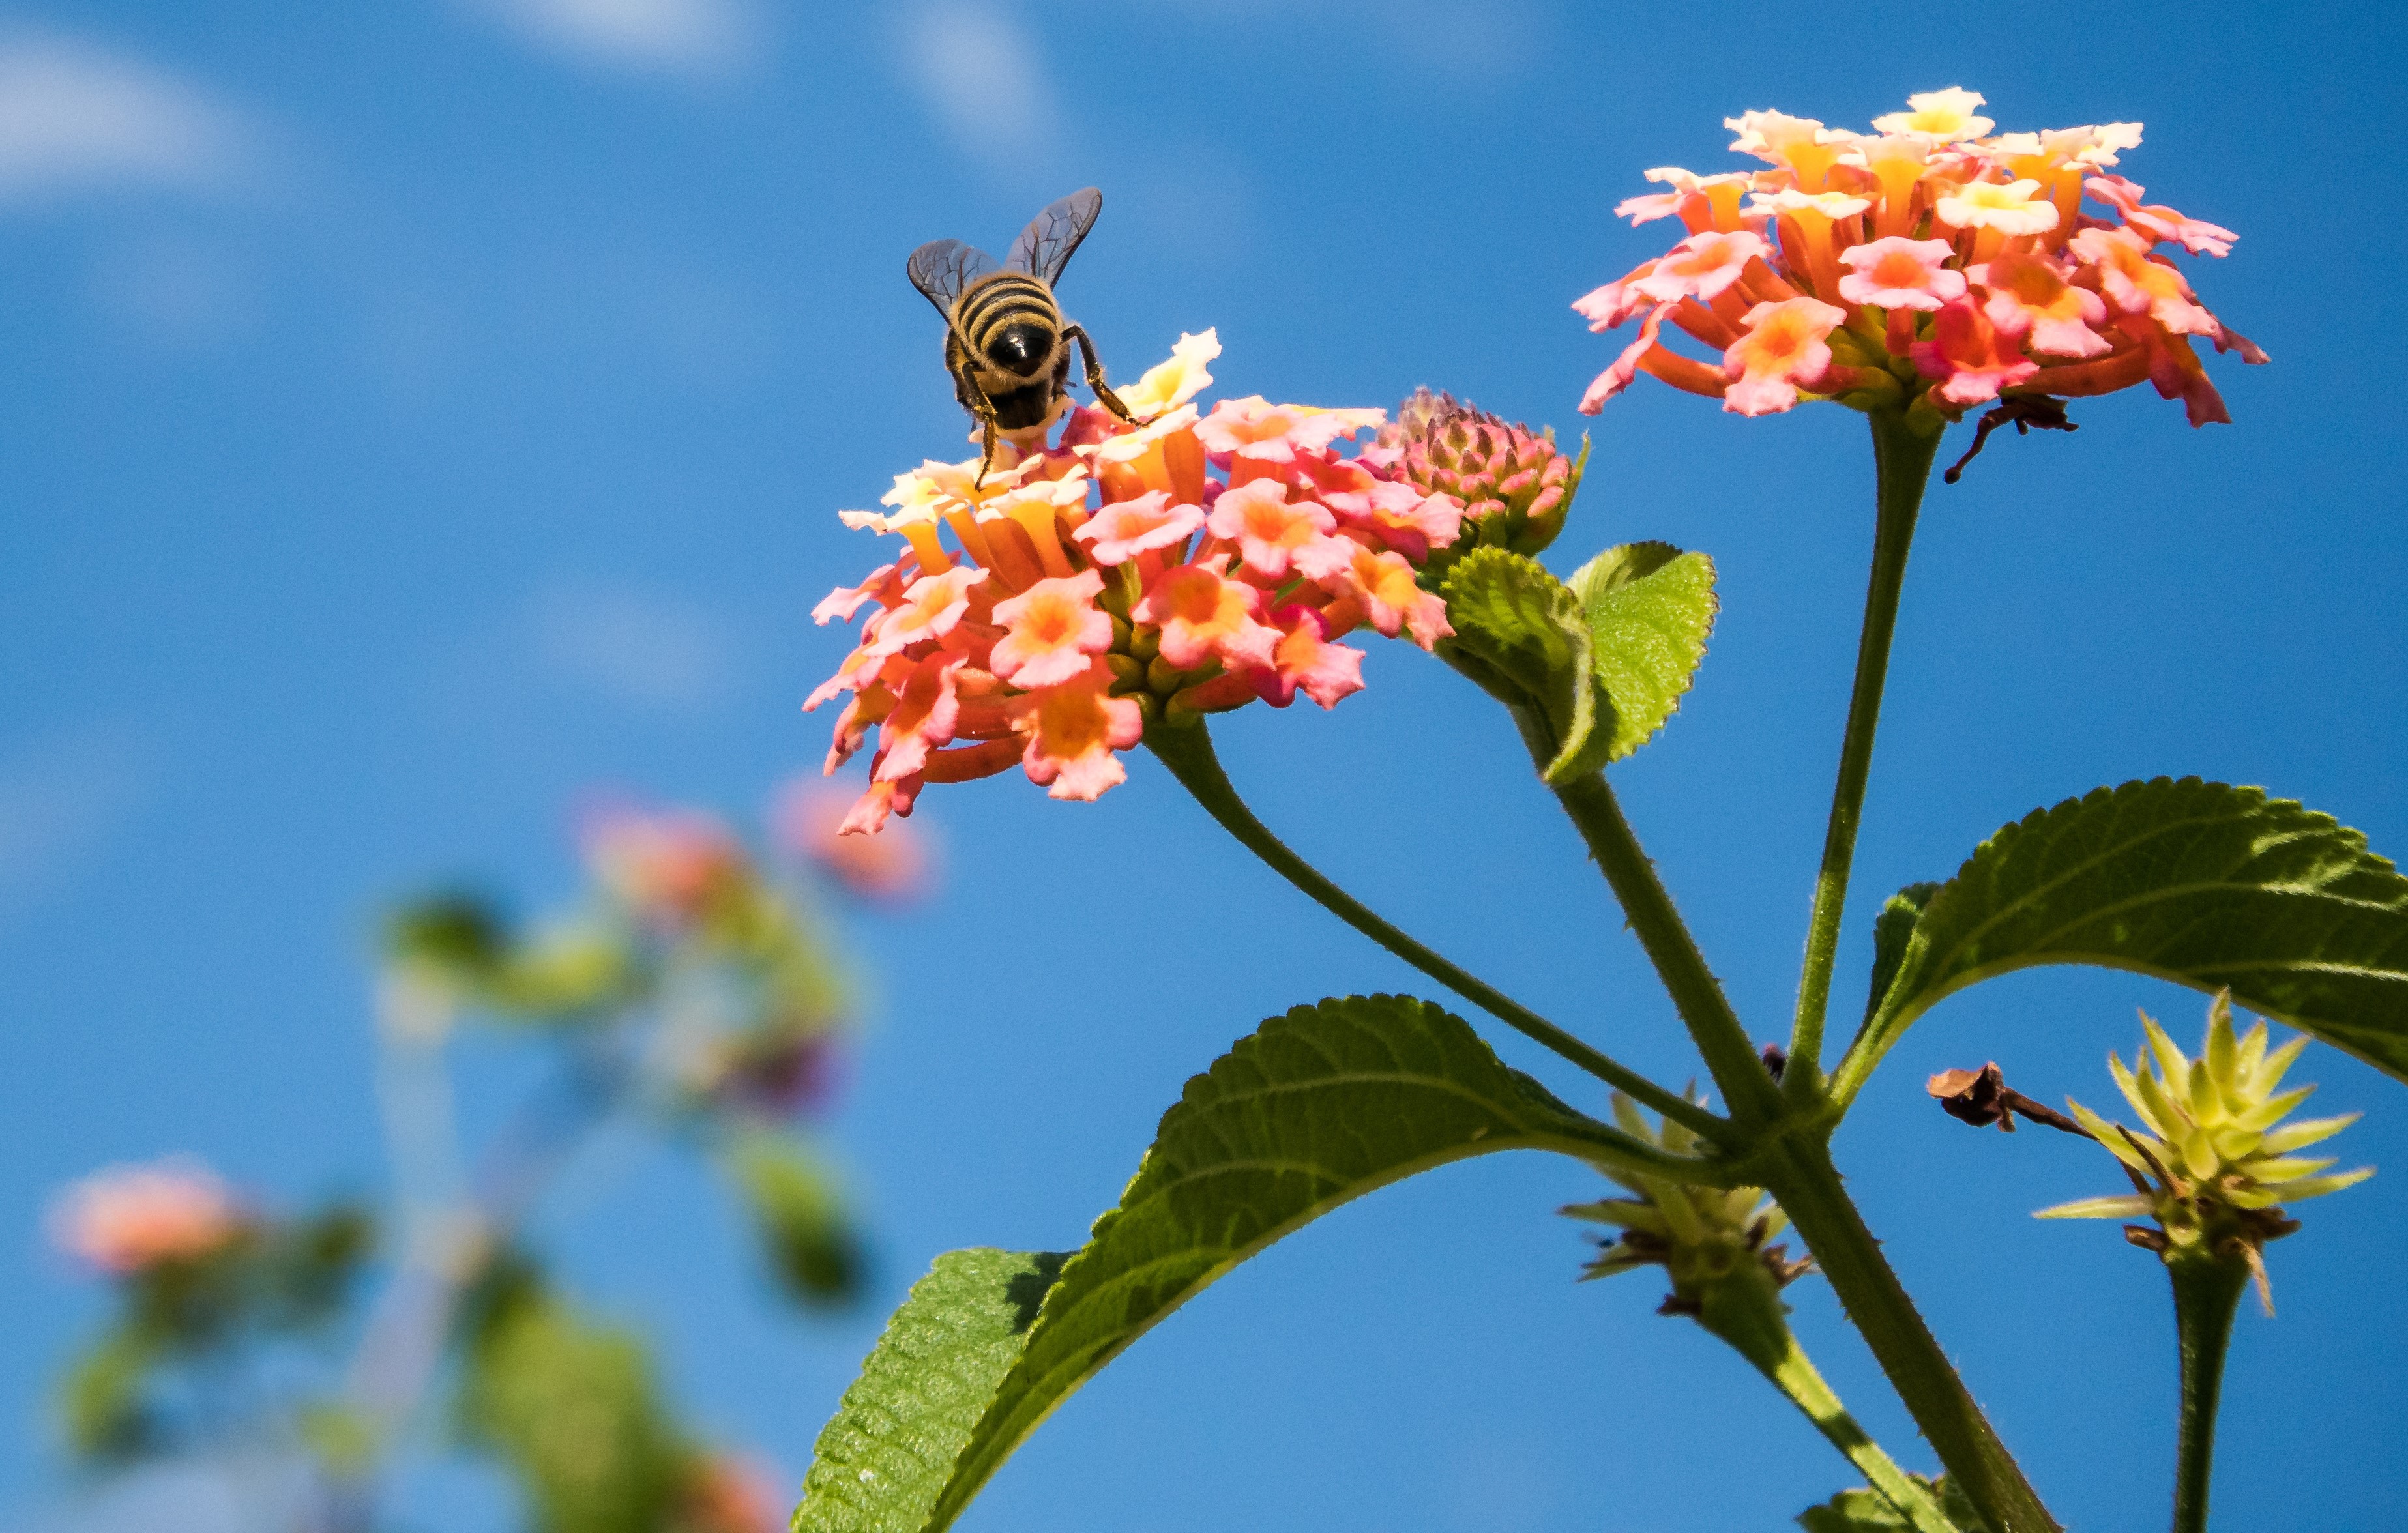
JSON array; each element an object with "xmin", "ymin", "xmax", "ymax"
[{"xmin": 795, "ymin": 997, "xmax": 1613, "ymax": 1533}]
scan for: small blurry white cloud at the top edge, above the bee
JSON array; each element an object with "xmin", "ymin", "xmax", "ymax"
[{"xmin": 903, "ymin": 5, "xmax": 1062, "ymax": 171}]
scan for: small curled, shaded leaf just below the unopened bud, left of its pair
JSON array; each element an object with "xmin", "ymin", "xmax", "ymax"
[{"xmin": 1440, "ymin": 549, "xmax": 1613, "ymax": 782}]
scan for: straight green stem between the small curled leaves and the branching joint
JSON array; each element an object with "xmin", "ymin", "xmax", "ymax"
[{"xmin": 1555, "ymin": 772, "xmax": 1782, "ymax": 1124}]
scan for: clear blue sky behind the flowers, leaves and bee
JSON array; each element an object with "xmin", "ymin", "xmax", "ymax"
[{"xmin": 0, "ymin": 0, "xmax": 2408, "ymax": 1533}]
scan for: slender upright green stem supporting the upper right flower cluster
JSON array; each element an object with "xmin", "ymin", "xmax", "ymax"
[{"xmin": 1784, "ymin": 409, "xmax": 1941, "ymax": 1078}]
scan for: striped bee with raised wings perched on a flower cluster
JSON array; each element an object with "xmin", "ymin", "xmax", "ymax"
[{"xmin": 905, "ymin": 188, "xmax": 1132, "ymax": 484}]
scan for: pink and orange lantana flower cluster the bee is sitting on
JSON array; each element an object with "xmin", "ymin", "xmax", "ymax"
[{"xmin": 804, "ymin": 330, "xmax": 1464, "ymax": 833}]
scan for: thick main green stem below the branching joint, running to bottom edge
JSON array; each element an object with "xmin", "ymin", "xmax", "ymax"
[{"xmin": 1758, "ymin": 1136, "xmax": 2057, "ymax": 1533}]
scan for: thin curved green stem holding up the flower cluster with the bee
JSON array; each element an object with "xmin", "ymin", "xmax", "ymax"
[{"xmin": 1146, "ymin": 722, "xmax": 1731, "ymax": 1143}]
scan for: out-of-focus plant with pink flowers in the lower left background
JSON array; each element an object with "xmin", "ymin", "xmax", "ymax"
[{"xmin": 51, "ymin": 782, "xmax": 932, "ymax": 1533}]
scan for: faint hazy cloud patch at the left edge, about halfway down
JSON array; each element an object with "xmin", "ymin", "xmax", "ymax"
[{"xmin": 0, "ymin": 724, "xmax": 154, "ymax": 917}]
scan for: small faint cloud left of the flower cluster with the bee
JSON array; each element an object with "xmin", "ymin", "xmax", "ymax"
[{"xmin": 527, "ymin": 580, "xmax": 737, "ymax": 710}]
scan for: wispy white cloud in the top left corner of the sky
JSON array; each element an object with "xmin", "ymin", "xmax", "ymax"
[{"xmin": 0, "ymin": 34, "xmax": 253, "ymax": 202}]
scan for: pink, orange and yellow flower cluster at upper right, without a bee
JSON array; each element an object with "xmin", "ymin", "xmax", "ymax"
[{"xmin": 1572, "ymin": 87, "xmax": 2266, "ymax": 426}]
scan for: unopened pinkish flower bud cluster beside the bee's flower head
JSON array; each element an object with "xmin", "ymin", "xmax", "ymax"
[{"xmin": 1365, "ymin": 387, "xmax": 1589, "ymax": 575}]
